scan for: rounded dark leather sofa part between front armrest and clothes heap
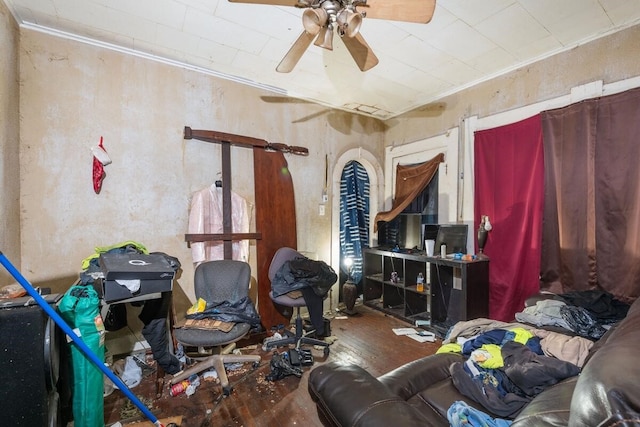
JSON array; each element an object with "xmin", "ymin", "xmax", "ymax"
[{"xmin": 378, "ymin": 353, "xmax": 464, "ymax": 403}]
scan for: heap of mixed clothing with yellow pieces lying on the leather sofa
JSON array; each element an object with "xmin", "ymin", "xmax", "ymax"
[{"xmin": 438, "ymin": 290, "xmax": 629, "ymax": 419}]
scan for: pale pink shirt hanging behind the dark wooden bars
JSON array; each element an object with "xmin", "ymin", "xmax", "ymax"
[{"xmin": 189, "ymin": 185, "xmax": 250, "ymax": 263}]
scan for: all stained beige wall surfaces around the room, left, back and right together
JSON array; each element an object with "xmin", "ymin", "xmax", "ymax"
[{"xmin": 7, "ymin": 17, "xmax": 640, "ymax": 308}]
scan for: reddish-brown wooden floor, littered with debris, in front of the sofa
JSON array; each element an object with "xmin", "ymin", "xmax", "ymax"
[{"xmin": 105, "ymin": 305, "xmax": 441, "ymax": 427}]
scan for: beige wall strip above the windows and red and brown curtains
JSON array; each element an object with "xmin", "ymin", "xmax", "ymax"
[{"xmin": 385, "ymin": 25, "xmax": 640, "ymax": 146}]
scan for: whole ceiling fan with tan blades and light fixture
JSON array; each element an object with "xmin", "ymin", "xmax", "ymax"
[{"xmin": 229, "ymin": 0, "xmax": 436, "ymax": 73}]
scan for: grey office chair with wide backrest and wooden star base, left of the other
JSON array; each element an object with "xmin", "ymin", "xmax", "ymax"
[{"xmin": 171, "ymin": 260, "xmax": 261, "ymax": 396}]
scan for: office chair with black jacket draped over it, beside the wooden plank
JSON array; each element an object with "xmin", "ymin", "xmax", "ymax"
[{"xmin": 266, "ymin": 247, "xmax": 329, "ymax": 357}]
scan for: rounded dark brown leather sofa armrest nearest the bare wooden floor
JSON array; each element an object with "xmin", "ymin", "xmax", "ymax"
[{"xmin": 309, "ymin": 362, "xmax": 440, "ymax": 427}]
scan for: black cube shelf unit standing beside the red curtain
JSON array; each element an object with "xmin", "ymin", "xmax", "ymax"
[{"xmin": 363, "ymin": 248, "xmax": 489, "ymax": 325}]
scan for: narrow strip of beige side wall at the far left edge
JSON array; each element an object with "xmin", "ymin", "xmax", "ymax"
[{"xmin": 0, "ymin": 2, "xmax": 21, "ymax": 286}]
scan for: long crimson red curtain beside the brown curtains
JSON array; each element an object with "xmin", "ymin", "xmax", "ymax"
[{"xmin": 474, "ymin": 115, "xmax": 544, "ymax": 321}]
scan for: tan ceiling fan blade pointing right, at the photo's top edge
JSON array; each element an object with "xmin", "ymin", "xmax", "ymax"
[{"xmin": 358, "ymin": 0, "xmax": 436, "ymax": 24}]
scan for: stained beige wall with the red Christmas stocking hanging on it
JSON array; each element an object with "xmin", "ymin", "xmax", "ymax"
[{"xmin": 20, "ymin": 30, "xmax": 383, "ymax": 299}]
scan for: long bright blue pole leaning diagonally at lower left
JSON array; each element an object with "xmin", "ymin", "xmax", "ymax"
[{"xmin": 0, "ymin": 251, "xmax": 162, "ymax": 427}]
